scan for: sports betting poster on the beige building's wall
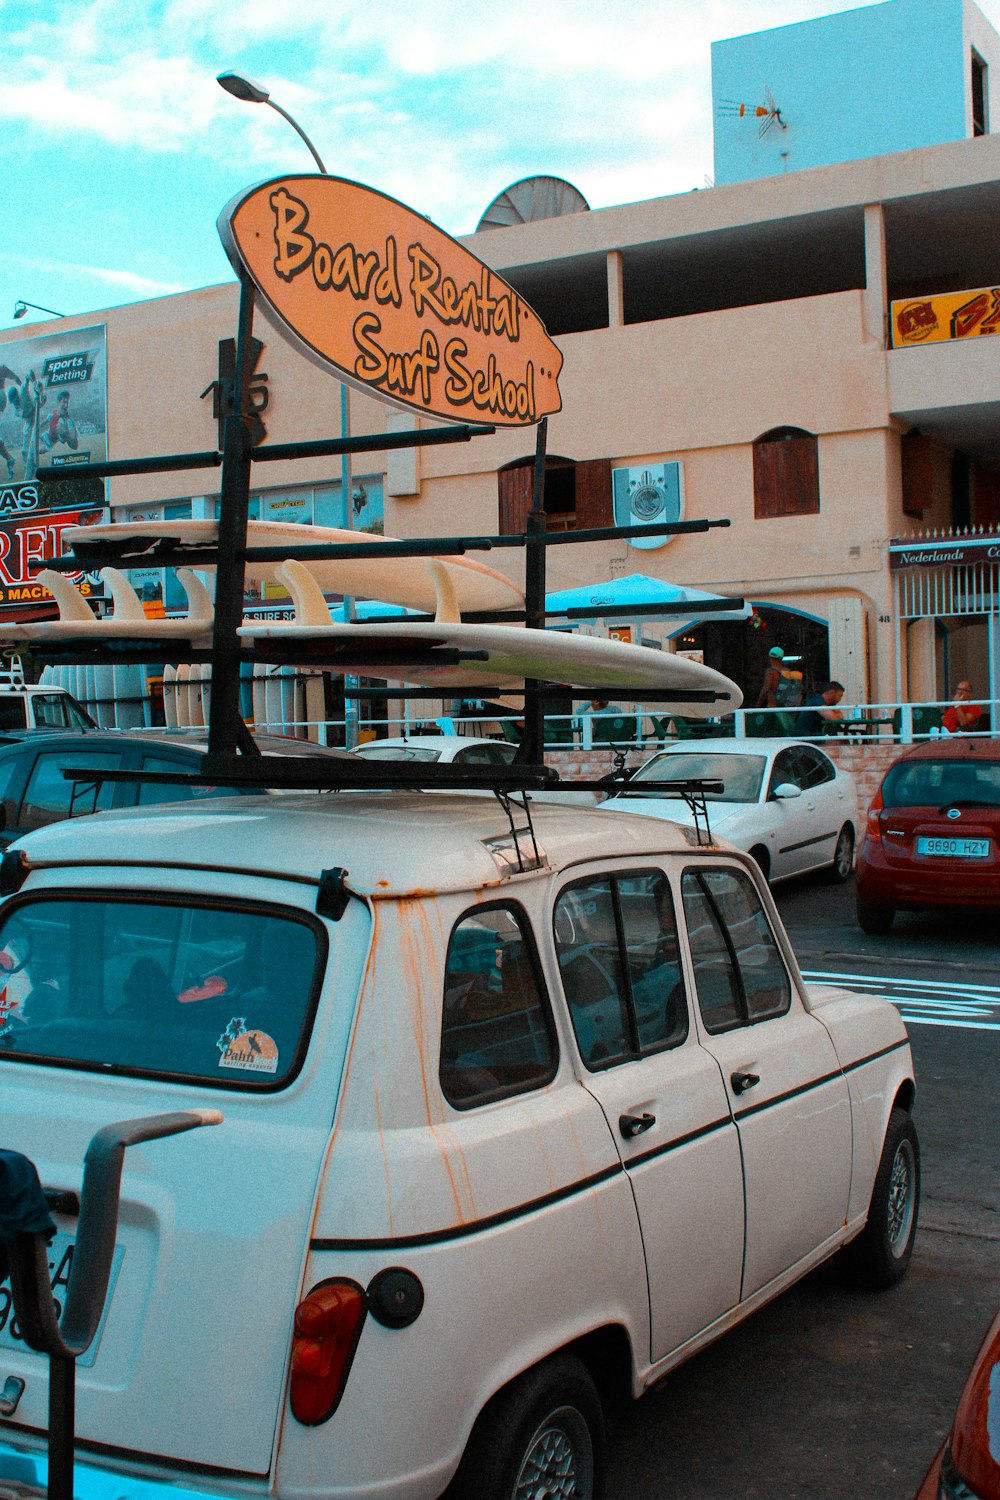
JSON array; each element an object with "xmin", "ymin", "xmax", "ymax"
[{"xmin": 0, "ymin": 324, "xmax": 108, "ymax": 489}]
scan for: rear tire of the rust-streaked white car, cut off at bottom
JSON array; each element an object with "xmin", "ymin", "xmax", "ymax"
[{"xmin": 445, "ymin": 1355, "xmax": 604, "ymax": 1500}]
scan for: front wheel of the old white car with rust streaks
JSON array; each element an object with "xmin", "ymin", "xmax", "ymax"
[{"xmin": 841, "ymin": 1109, "xmax": 921, "ymax": 1292}]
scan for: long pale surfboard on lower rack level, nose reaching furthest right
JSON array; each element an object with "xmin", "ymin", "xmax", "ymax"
[{"xmin": 240, "ymin": 621, "xmax": 742, "ymax": 719}]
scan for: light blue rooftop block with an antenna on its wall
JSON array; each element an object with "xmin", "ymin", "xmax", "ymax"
[{"xmin": 712, "ymin": 0, "xmax": 1000, "ymax": 185}]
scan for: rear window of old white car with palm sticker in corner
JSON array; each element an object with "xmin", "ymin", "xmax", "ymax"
[{"xmin": 0, "ymin": 896, "xmax": 325, "ymax": 1089}]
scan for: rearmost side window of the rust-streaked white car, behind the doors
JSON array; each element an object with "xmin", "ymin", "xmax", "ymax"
[{"xmin": 439, "ymin": 905, "xmax": 558, "ymax": 1110}]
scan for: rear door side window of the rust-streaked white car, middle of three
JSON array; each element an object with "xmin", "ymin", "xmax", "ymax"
[{"xmin": 553, "ymin": 872, "xmax": 688, "ymax": 1073}]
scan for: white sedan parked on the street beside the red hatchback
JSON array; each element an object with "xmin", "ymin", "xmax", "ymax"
[{"xmin": 604, "ymin": 740, "xmax": 858, "ymax": 881}]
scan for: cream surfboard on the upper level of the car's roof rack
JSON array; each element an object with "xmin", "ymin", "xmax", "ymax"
[{"xmin": 59, "ymin": 521, "xmax": 525, "ymax": 612}]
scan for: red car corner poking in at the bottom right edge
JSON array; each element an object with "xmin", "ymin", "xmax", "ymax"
[{"xmin": 915, "ymin": 1317, "xmax": 1000, "ymax": 1500}]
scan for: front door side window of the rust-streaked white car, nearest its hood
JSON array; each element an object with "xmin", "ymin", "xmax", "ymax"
[{"xmin": 681, "ymin": 867, "xmax": 792, "ymax": 1032}]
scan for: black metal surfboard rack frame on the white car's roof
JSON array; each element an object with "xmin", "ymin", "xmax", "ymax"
[{"xmin": 27, "ymin": 273, "xmax": 744, "ymax": 815}]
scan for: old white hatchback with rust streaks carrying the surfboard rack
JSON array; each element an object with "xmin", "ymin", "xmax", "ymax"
[{"xmin": 0, "ymin": 791, "xmax": 919, "ymax": 1500}]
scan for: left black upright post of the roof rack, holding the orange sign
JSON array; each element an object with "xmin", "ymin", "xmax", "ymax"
[{"xmin": 208, "ymin": 275, "xmax": 253, "ymax": 762}]
